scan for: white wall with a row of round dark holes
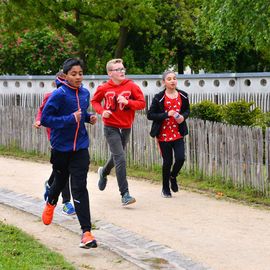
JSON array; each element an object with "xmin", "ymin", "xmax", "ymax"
[{"xmin": 0, "ymin": 72, "xmax": 270, "ymax": 94}]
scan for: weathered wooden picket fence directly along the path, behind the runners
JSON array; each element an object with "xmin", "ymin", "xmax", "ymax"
[{"xmin": 0, "ymin": 106, "xmax": 270, "ymax": 196}]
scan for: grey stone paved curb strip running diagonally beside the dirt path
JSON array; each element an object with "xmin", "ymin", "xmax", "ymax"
[{"xmin": 0, "ymin": 188, "xmax": 210, "ymax": 270}]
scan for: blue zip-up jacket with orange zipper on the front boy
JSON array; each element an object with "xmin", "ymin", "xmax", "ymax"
[{"xmin": 41, "ymin": 82, "xmax": 91, "ymax": 152}]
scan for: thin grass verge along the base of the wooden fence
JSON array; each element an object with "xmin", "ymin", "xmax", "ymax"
[{"xmin": 0, "ymin": 146, "xmax": 270, "ymax": 207}]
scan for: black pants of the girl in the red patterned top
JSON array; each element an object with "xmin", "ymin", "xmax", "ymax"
[{"xmin": 159, "ymin": 139, "xmax": 185, "ymax": 191}]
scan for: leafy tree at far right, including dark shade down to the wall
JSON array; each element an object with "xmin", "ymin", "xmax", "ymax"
[{"xmin": 196, "ymin": 0, "xmax": 270, "ymax": 72}]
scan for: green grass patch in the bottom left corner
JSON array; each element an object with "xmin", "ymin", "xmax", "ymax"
[{"xmin": 0, "ymin": 222, "xmax": 75, "ymax": 270}]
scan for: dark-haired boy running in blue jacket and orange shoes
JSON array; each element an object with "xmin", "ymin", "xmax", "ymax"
[{"xmin": 41, "ymin": 58, "xmax": 97, "ymax": 248}]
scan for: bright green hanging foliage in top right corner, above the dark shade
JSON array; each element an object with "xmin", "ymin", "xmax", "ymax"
[{"xmin": 197, "ymin": 0, "xmax": 270, "ymax": 50}]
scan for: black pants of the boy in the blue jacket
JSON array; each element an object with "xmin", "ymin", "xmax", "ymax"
[{"xmin": 48, "ymin": 149, "xmax": 91, "ymax": 232}]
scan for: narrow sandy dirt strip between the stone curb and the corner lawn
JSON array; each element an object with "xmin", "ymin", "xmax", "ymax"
[{"xmin": 0, "ymin": 204, "xmax": 139, "ymax": 270}]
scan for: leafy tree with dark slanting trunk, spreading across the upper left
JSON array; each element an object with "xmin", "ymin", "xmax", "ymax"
[{"xmin": 1, "ymin": 0, "xmax": 155, "ymax": 72}]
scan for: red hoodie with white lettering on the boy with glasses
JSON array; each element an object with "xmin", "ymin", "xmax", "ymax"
[{"xmin": 91, "ymin": 79, "xmax": 145, "ymax": 128}]
